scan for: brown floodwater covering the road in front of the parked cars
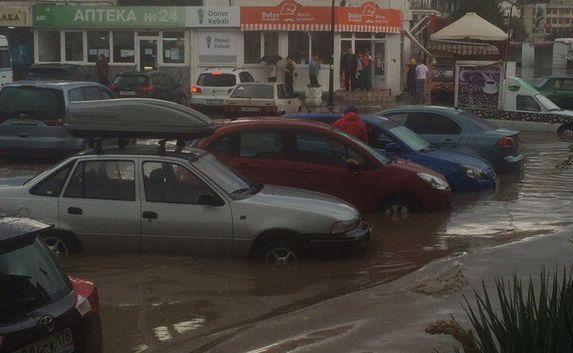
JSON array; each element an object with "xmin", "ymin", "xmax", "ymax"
[{"xmin": 0, "ymin": 133, "xmax": 573, "ymax": 353}]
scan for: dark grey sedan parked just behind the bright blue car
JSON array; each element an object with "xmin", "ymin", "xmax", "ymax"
[{"xmin": 378, "ymin": 106, "xmax": 524, "ymax": 172}]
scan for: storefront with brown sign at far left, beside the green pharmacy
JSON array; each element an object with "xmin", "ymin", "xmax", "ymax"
[{"xmin": 0, "ymin": 7, "xmax": 33, "ymax": 79}]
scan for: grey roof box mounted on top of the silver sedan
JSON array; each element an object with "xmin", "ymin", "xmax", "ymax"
[{"xmin": 66, "ymin": 98, "xmax": 215, "ymax": 140}]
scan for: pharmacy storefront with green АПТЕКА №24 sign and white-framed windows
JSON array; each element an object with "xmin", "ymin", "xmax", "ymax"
[{"xmin": 33, "ymin": 5, "xmax": 190, "ymax": 84}]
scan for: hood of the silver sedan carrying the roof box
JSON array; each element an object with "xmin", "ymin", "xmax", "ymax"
[{"xmin": 245, "ymin": 185, "xmax": 359, "ymax": 220}]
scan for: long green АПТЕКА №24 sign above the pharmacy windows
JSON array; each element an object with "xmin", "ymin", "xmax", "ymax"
[{"xmin": 32, "ymin": 4, "xmax": 185, "ymax": 28}]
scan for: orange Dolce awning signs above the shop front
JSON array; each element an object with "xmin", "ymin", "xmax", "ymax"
[{"xmin": 241, "ymin": 0, "xmax": 402, "ymax": 33}]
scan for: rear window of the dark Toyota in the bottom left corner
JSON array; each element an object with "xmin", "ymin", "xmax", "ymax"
[{"xmin": 0, "ymin": 238, "xmax": 71, "ymax": 323}]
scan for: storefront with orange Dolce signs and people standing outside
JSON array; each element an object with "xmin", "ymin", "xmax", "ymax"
[{"xmin": 240, "ymin": 0, "xmax": 402, "ymax": 94}]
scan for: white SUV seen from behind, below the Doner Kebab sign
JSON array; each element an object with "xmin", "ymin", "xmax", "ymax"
[{"xmin": 191, "ymin": 68, "xmax": 255, "ymax": 109}]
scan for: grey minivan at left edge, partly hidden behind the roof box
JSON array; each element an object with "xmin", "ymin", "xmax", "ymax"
[{"xmin": 0, "ymin": 81, "xmax": 113, "ymax": 156}]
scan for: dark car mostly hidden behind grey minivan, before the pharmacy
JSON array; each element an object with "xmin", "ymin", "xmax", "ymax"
[{"xmin": 24, "ymin": 64, "xmax": 95, "ymax": 81}]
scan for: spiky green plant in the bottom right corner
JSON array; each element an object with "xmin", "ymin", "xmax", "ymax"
[{"xmin": 426, "ymin": 271, "xmax": 573, "ymax": 353}]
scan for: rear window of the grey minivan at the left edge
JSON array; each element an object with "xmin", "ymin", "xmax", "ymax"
[{"xmin": 0, "ymin": 86, "xmax": 65, "ymax": 118}]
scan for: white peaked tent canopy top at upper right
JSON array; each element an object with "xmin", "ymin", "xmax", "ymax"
[{"xmin": 430, "ymin": 12, "xmax": 507, "ymax": 41}]
